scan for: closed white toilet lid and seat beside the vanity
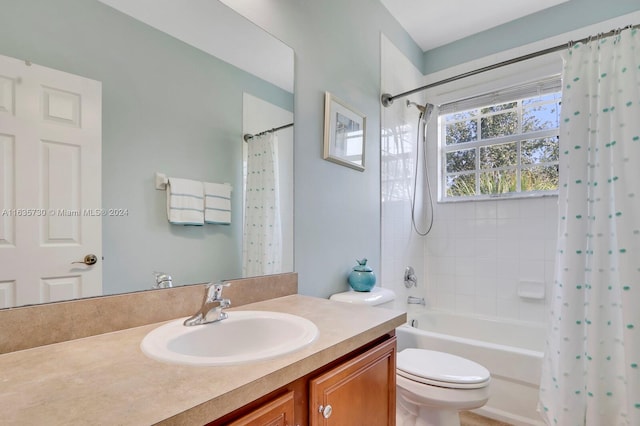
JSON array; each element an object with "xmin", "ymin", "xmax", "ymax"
[{"xmin": 396, "ymin": 348, "xmax": 491, "ymax": 388}]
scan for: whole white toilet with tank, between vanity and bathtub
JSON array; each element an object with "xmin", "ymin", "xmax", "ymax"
[{"xmin": 330, "ymin": 287, "xmax": 491, "ymax": 426}]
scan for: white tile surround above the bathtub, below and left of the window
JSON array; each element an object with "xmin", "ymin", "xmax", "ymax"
[{"xmin": 380, "ymin": 36, "xmax": 557, "ymax": 322}]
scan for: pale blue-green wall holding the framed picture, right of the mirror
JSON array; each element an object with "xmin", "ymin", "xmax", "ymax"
[{"xmin": 238, "ymin": 0, "xmax": 421, "ymax": 297}]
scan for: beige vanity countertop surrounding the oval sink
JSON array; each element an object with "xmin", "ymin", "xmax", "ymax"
[{"xmin": 0, "ymin": 295, "xmax": 405, "ymax": 425}]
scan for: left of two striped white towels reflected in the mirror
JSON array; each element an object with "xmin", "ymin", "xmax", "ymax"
[{"xmin": 167, "ymin": 177, "xmax": 204, "ymax": 225}]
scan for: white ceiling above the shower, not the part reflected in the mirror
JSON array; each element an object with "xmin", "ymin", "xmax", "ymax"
[{"xmin": 380, "ymin": 0, "xmax": 569, "ymax": 51}]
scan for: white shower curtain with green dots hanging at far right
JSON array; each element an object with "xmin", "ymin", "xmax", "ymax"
[{"xmin": 539, "ymin": 29, "xmax": 640, "ymax": 426}]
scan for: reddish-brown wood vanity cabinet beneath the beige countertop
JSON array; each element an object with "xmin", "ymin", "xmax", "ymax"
[{"xmin": 209, "ymin": 335, "xmax": 396, "ymax": 426}]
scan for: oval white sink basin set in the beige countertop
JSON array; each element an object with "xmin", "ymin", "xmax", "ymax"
[{"xmin": 140, "ymin": 311, "xmax": 318, "ymax": 366}]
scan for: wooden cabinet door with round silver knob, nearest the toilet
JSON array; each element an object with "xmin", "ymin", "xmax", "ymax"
[{"xmin": 309, "ymin": 337, "xmax": 396, "ymax": 426}]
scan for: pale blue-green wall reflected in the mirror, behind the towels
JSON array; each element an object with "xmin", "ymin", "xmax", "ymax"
[{"xmin": 0, "ymin": 0, "xmax": 293, "ymax": 293}]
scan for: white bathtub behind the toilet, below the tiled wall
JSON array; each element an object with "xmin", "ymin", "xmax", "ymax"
[{"xmin": 396, "ymin": 310, "xmax": 546, "ymax": 426}]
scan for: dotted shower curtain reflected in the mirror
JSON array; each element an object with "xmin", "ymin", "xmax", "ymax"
[{"xmin": 242, "ymin": 133, "xmax": 282, "ymax": 277}]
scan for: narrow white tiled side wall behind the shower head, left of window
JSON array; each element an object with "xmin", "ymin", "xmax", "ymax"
[{"xmin": 380, "ymin": 35, "xmax": 430, "ymax": 310}]
